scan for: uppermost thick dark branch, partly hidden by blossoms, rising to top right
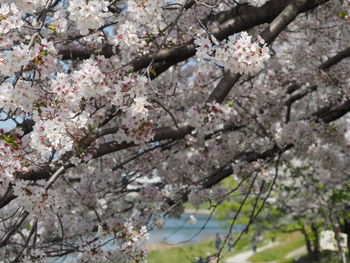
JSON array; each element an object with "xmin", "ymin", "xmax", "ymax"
[{"xmin": 59, "ymin": 0, "xmax": 328, "ymax": 76}]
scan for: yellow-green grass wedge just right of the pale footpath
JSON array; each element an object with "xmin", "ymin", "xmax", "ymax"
[{"xmin": 249, "ymin": 233, "xmax": 305, "ymax": 263}]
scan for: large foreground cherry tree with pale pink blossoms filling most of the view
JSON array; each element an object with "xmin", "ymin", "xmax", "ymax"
[{"xmin": 0, "ymin": 0, "xmax": 350, "ymax": 262}]
